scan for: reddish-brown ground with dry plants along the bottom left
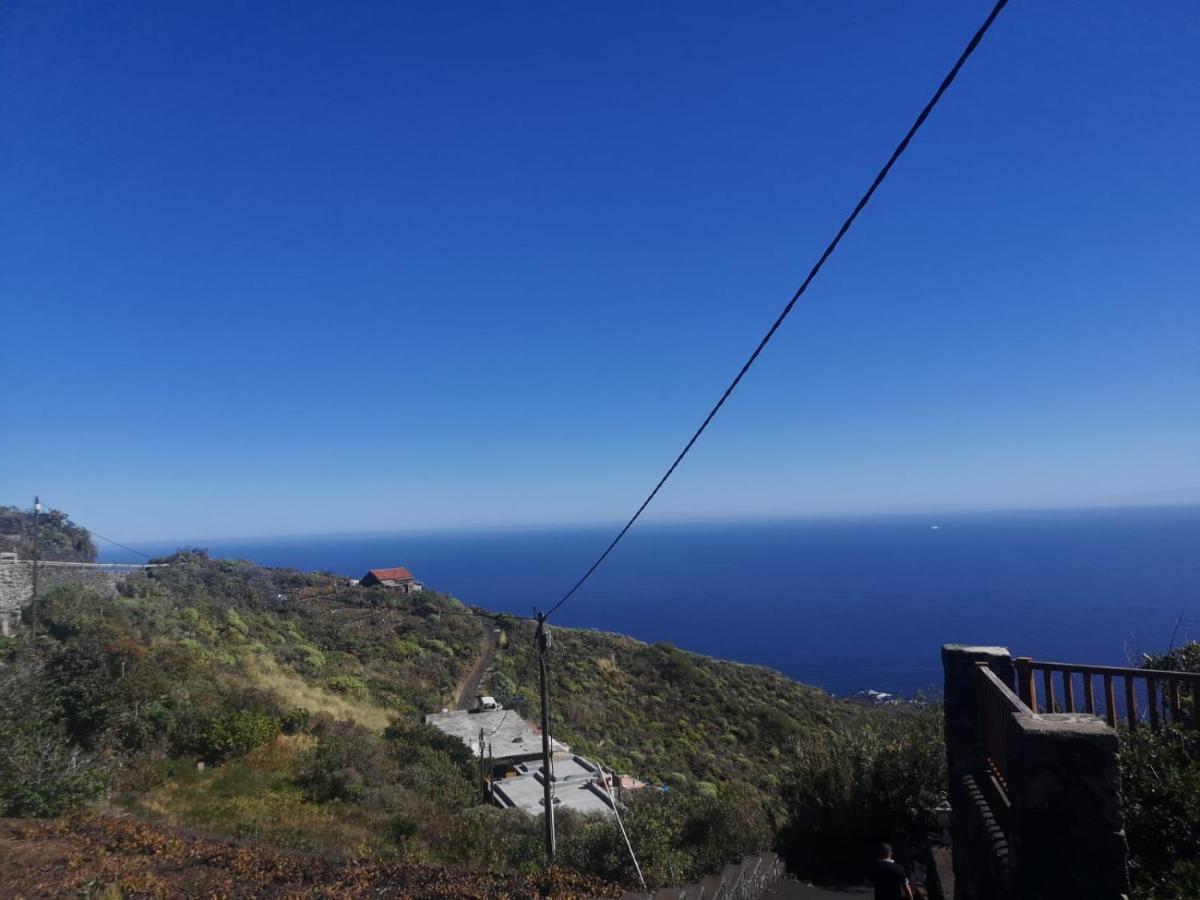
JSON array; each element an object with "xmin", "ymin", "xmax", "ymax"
[{"xmin": 0, "ymin": 817, "xmax": 620, "ymax": 900}]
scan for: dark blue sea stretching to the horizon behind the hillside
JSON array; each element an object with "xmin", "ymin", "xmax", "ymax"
[{"xmin": 102, "ymin": 506, "xmax": 1200, "ymax": 695}]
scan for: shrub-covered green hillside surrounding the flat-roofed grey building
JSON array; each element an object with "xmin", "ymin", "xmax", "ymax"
[{"xmin": 0, "ymin": 551, "xmax": 936, "ymax": 884}]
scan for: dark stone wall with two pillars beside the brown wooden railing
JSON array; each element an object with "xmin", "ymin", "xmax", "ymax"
[{"xmin": 942, "ymin": 644, "xmax": 1128, "ymax": 900}]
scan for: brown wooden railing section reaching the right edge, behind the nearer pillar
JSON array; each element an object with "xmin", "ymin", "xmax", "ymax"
[{"xmin": 1014, "ymin": 656, "xmax": 1200, "ymax": 730}]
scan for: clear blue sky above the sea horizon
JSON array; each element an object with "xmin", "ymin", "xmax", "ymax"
[{"xmin": 0, "ymin": 0, "xmax": 1200, "ymax": 540}]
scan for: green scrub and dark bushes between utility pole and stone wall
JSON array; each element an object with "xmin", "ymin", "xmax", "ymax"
[{"xmin": 492, "ymin": 617, "xmax": 946, "ymax": 883}]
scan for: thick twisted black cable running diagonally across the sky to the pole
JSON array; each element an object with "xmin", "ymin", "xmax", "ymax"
[{"xmin": 546, "ymin": 0, "xmax": 1008, "ymax": 617}]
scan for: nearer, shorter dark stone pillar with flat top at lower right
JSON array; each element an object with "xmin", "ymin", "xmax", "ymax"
[{"xmin": 1008, "ymin": 714, "xmax": 1129, "ymax": 900}]
